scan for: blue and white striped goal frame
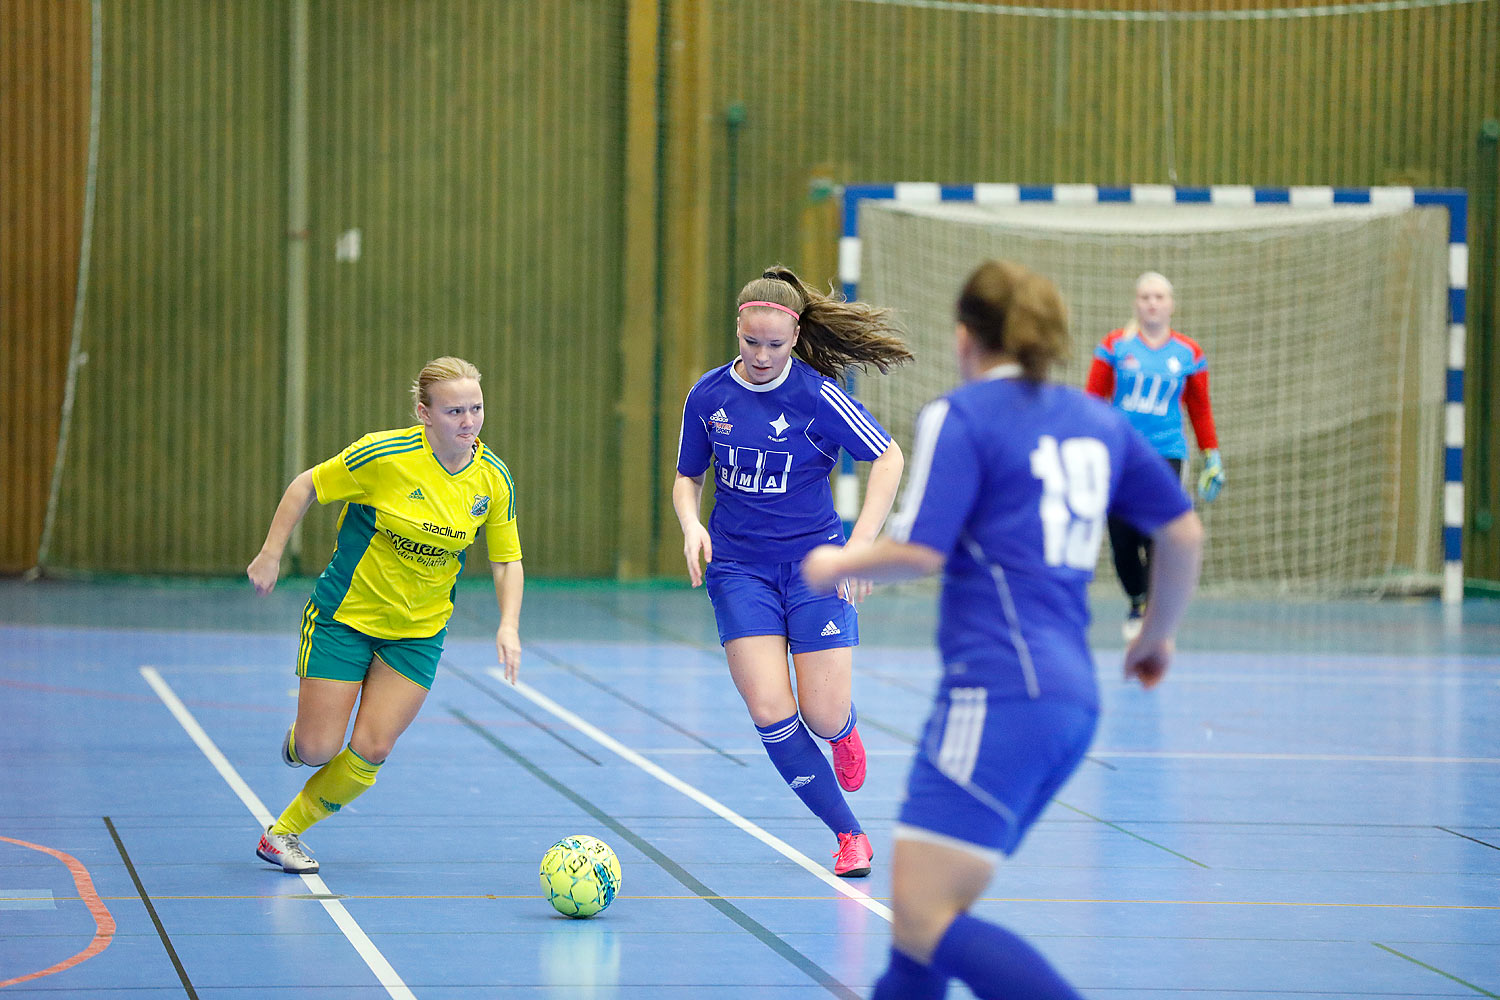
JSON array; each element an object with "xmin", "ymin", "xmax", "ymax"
[{"xmin": 836, "ymin": 183, "xmax": 1469, "ymax": 604}]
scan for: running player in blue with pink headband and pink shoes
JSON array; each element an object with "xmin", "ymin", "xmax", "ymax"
[{"xmin": 672, "ymin": 267, "xmax": 911, "ymax": 879}]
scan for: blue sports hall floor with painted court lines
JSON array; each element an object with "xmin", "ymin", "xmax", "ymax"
[{"xmin": 0, "ymin": 579, "xmax": 1500, "ymax": 1000}]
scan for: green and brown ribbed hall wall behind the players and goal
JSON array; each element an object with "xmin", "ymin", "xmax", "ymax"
[{"xmin": 0, "ymin": 0, "xmax": 1500, "ymax": 576}]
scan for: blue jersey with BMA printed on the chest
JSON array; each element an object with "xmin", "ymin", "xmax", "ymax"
[{"xmin": 677, "ymin": 357, "xmax": 891, "ymax": 562}]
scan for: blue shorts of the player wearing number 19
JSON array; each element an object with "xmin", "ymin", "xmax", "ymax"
[{"xmin": 900, "ymin": 688, "xmax": 1100, "ymax": 855}]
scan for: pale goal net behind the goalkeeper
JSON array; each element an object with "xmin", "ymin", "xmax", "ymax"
[{"xmin": 858, "ymin": 201, "xmax": 1448, "ymax": 595}]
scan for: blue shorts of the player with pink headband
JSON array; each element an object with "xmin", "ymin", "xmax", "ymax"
[{"xmin": 704, "ymin": 559, "xmax": 860, "ymax": 652}]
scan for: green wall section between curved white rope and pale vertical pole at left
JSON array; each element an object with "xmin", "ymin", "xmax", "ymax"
[{"xmin": 50, "ymin": 0, "xmax": 287, "ymax": 573}]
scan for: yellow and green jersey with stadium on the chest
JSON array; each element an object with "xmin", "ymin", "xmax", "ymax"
[{"xmin": 312, "ymin": 424, "xmax": 521, "ymax": 639}]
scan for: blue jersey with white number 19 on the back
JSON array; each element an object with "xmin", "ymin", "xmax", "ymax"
[{"xmin": 888, "ymin": 364, "xmax": 1191, "ymax": 709}]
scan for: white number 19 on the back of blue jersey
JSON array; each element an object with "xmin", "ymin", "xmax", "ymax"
[{"xmin": 1031, "ymin": 435, "xmax": 1110, "ymax": 570}]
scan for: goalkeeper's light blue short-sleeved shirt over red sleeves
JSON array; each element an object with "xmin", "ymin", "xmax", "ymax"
[{"xmin": 1094, "ymin": 330, "xmax": 1208, "ymax": 459}]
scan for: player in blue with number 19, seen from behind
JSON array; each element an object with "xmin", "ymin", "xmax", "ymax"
[{"xmin": 803, "ymin": 261, "xmax": 1203, "ymax": 1000}]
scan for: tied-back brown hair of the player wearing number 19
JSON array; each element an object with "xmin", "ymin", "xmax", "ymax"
[{"xmin": 954, "ymin": 261, "xmax": 1068, "ymax": 382}]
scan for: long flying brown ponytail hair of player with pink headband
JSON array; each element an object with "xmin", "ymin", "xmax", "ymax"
[{"xmin": 735, "ymin": 264, "xmax": 912, "ymax": 378}]
